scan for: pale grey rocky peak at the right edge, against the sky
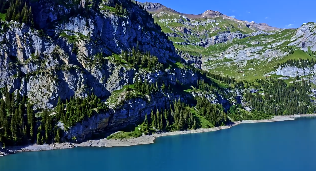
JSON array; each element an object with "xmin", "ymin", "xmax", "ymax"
[{"xmin": 289, "ymin": 23, "xmax": 316, "ymax": 51}]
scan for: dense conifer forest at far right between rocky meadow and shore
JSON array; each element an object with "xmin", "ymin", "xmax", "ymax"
[{"xmin": 244, "ymin": 79, "xmax": 316, "ymax": 115}]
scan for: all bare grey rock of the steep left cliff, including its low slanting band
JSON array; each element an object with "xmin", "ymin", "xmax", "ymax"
[{"xmin": 0, "ymin": 0, "xmax": 237, "ymax": 141}]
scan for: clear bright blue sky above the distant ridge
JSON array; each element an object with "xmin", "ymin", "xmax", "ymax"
[{"xmin": 138, "ymin": 0, "xmax": 316, "ymax": 28}]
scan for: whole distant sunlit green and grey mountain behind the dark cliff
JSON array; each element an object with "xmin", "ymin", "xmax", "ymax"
[{"xmin": 142, "ymin": 2, "xmax": 316, "ymax": 81}]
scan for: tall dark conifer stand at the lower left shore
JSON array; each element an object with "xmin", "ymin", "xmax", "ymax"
[{"xmin": 0, "ymin": 91, "xmax": 62, "ymax": 146}]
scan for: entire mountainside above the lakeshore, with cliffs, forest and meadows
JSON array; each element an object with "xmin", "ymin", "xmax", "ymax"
[{"xmin": 0, "ymin": 0, "xmax": 316, "ymax": 148}]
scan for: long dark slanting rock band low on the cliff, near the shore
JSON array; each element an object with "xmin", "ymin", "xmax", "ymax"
[{"xmin": 64, "ymin": 93, "xmax": 180, "ymax": 142}]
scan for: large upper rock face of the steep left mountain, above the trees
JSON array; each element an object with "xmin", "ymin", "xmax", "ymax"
[{"xmin": 0, "ymin": 0, "xmax": 177, "ymax": 108}]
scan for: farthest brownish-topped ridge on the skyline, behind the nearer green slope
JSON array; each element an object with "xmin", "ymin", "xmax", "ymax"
[{"xmin": 141, "ymin": 2, "xmax": 280, "ymax": 38}]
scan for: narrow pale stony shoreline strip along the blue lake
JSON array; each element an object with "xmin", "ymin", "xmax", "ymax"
[{"xmin": 0, "ymin": 114, "xmax": 316, "ymax": 157}]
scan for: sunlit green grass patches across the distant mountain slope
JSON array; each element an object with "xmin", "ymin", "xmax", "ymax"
[{"xmin": 154, "ymin": 12, "xmax": 312, "ymax": 81}]
